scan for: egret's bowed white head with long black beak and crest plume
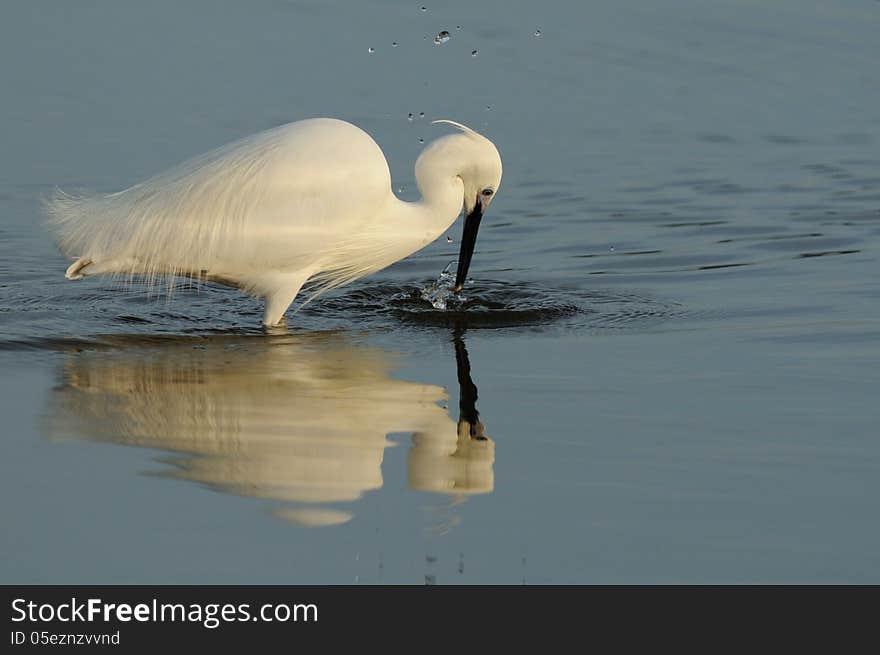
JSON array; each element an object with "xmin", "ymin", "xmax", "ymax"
[{"xmin": 416, "ymin": 120, "xmax": 502, "ymax": 292}]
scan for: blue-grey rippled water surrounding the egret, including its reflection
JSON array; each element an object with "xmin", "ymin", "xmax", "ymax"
[{"xmin": 0, "ymin": 0, "xmax": 880, "ymax": 583}]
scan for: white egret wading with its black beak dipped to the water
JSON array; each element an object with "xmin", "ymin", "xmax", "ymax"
[{"xmin": 47, "ymin": 118, "xmax": 502, "ymax": 325}]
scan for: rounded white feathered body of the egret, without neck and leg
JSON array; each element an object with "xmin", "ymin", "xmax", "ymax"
[{"xmin": 47, "ymin": 119, "xmax": 391, "ymax": 292}]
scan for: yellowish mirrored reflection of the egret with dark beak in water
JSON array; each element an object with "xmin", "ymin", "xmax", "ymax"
[{"xmin": 49, "ymin": 334, "xmax": 494, "ymax": 525}]
